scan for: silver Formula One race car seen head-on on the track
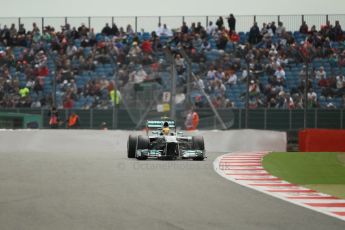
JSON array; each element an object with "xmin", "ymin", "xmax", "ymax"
[{"xmin": 127, "ymin": 119, "xmax": 206, "ymax": 161}]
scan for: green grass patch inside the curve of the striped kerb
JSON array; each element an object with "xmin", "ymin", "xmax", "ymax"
[{"xmin": 263, "ymin": 153, "xmax": 345, "ymax": 198}]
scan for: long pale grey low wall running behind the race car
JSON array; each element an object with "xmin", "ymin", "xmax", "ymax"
[{"xmin": 0, "ymin": 129, "xmax": 286, "ymax": 157}]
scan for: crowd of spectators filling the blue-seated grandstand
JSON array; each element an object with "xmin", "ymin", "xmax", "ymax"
[{"xmin": 0, "ymin": 14, "xmax": 345, "ymax": 109}]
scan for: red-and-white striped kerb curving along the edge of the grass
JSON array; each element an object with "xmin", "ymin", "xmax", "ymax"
[{"xmin": 213, "ymin": 152, "xmax": 345, "ymax": 221}]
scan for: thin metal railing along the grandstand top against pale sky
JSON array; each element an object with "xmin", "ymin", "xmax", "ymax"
[{"xmin": 0, "ymin": 14, "xmax": 345, "ymax": 32}]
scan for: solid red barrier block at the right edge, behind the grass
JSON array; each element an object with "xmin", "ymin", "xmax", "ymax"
[{"xmin": 298, "ymin": 129, "xmax": 345, "ymax": 152}]
